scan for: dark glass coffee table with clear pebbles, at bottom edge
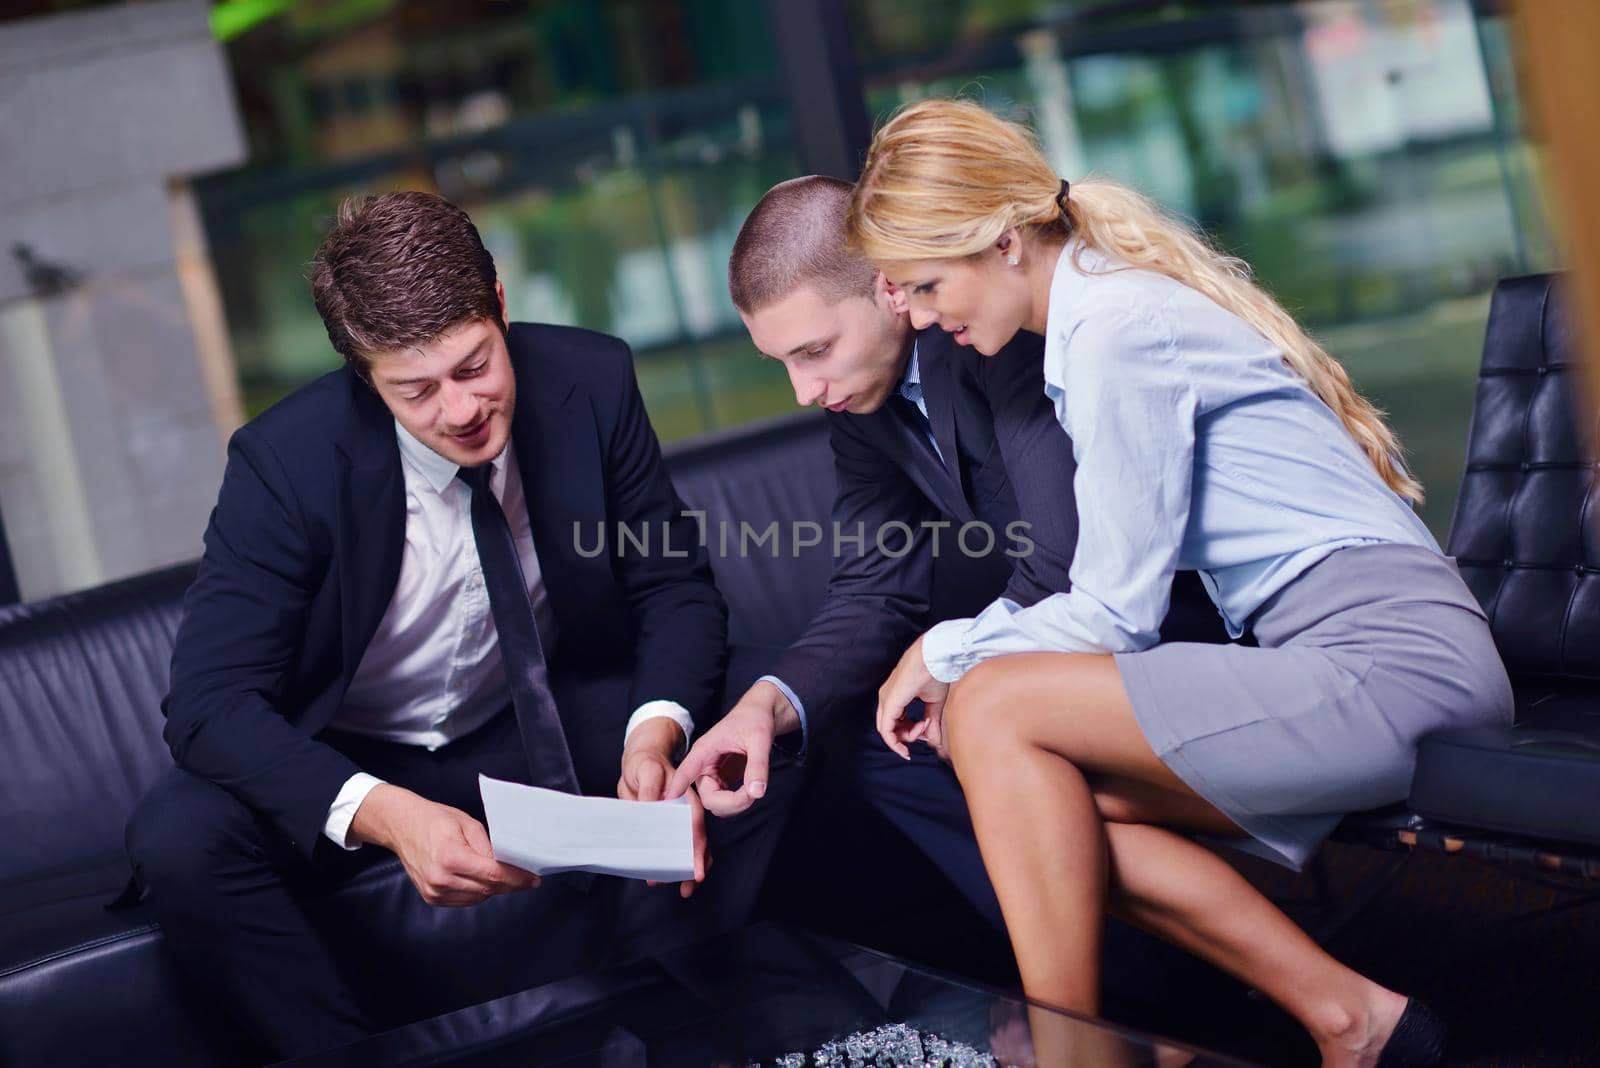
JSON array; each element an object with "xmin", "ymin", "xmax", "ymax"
[{"xmin": 290, "ymin": 924, "xmax": 1245, "ymax": 1068}]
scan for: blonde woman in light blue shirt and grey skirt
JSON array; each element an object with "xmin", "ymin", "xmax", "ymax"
[{"xmin": 850, "ymin": 101, "xmax": 1512, "ymax": 1066}]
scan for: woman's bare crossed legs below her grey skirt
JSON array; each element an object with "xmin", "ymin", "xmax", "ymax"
[{"xmin": 944, "ymin": 654, "xmax": 1405, "ymax": 1066}]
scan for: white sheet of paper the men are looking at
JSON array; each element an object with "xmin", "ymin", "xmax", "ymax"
[{"xmin": 478, "ymin": 775, "xmax": 694, "ymax": 883}]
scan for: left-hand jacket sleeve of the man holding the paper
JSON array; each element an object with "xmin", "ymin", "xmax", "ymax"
[{"xmin": 162, "ymin": 427, "xmax": 358, "ymax": 855}]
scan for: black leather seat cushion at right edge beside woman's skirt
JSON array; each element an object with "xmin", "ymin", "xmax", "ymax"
[{"xmin": 1411, "ymin": 687, "xmax": 1600, "ymax": 846}]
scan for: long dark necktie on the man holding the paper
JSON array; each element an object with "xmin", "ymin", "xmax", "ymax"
[{"xmin": 456, "ymin": 464, "xmax": 578, "ymax": 793}]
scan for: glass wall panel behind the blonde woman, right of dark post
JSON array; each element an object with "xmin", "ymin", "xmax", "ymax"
[{"xmin": 850, "ymin": 0, "xmax": 1555, "ymax": 539}]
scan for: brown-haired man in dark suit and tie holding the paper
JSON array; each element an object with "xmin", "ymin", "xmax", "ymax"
[{"xmin": 128, "ymin": 193, "xmax": 778, "ymax": 1055}]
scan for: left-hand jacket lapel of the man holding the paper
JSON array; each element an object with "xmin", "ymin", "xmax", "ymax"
[{"xmin": 336, "ymin": 373, "xmax": 405, "ymax": 686}]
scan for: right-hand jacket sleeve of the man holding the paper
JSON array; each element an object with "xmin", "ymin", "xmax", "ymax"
[{"xmin": 603, "ymin": 342, "xmax": 728, "ymax": 724}]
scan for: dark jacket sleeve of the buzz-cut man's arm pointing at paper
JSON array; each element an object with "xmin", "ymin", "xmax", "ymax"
[{"xmin": 773, "ymin": 416, "xmax": 949, "ymax": 740}]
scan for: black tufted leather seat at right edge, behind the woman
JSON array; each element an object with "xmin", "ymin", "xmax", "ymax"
[{"xmin": 1341, "ymin": 275, "xmax": 1600, "ymax": 887}]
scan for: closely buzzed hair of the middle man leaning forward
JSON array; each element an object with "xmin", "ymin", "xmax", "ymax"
[{"xmin": 728, "ymin": 174, "xmax": 877, "ymax": 315}]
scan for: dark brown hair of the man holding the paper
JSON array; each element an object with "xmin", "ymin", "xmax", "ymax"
[{"xmin": 310, "ymin": 192, "xmax": 502, "ymax": 377}]
